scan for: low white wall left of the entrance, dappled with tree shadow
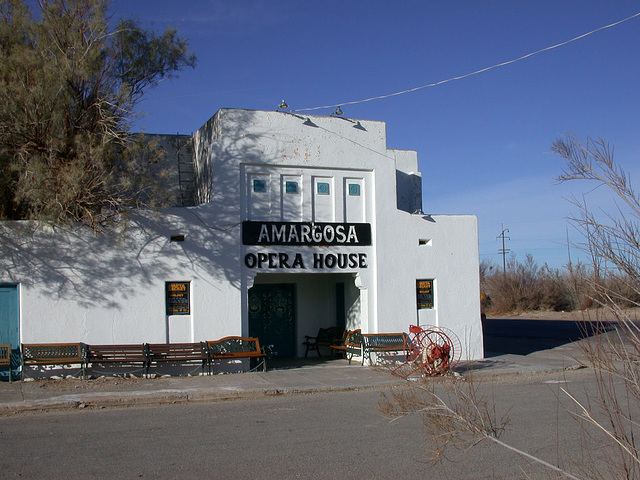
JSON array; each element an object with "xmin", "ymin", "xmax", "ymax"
[{"xmin": 0, "ymin": 209, "xmax": 241, "ymax": 343}]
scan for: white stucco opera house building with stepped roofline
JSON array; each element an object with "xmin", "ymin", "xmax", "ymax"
[{"xmin": 0, "ymin": 109, "xmax": 483, "ymax": 364}]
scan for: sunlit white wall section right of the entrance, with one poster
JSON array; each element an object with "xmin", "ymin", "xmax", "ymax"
[{"xmin": 378, "ymin": 214, "xmax": 483, "ymax": 358}]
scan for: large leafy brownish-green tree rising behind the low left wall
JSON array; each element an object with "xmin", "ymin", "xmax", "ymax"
[{"xmin": 0, "ymin": 0, "xmax": 196, "ymax": 229}]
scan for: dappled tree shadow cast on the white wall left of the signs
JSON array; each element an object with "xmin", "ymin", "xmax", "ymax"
[{"xmin": 0, "ymin": 111, "xmax": 272, "ymax": 309}]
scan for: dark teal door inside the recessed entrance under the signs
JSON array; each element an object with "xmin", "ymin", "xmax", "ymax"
[{"xmin": 249, "ymin": 283, "xmax": 296, "ymax": 357}]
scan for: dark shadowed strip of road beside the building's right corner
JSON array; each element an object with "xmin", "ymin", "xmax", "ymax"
[{"xmin": 482, "ymin": 318, "xmax": 609, "ymax": 357}]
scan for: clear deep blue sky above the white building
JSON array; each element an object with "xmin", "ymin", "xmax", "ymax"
[{"xmin": 111, "ymin": 0, "xmax": 640, "ymax": 267}]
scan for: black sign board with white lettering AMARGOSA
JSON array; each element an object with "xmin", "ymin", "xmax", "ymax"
[{"xmin": 242, "ymin": 222, "xmax": 371, "ymax": 246}]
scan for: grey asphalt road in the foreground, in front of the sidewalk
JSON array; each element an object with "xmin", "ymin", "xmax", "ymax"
[{"xmin": 0, "ymin": 370, "xmax": 604, "ymax": 480}]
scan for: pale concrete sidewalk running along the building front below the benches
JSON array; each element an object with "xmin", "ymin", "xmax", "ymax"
[{"xmin": 0, "ymin": 340, "xmax": 584, "ymax": 415}]
